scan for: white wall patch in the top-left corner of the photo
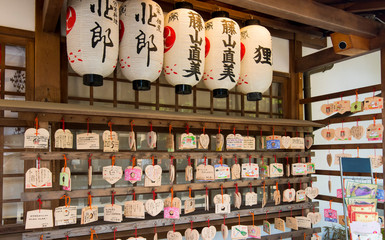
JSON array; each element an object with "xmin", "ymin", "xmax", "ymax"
[{"xmin": 0, "ymin": 0, "xmax": 35, "ymax": 31}]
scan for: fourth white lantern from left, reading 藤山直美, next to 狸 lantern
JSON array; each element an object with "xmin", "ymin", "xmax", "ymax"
[{"xmin": 203, "ymin": 11, "xmax": 241, "ymax": 98}]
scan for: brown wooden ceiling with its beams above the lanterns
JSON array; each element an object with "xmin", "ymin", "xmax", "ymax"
[{"xmin": 42, "ymin": 0, "xmax": 385, "ymax": 49}]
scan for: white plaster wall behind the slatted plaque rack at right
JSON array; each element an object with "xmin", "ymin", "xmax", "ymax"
[{"xmin": 303, "ymin": 39, "xmax": 383, "ymax": 238}]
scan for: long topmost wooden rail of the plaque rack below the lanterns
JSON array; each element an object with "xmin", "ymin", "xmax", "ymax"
[{"xmin": 0, "ymin": 100, "xmax": 323, "ymax": 127}]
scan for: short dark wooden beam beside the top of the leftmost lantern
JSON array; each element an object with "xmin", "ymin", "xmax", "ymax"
[{"xmin": 43, "ymin": 0, "xmax": 64, "ymax": 32}]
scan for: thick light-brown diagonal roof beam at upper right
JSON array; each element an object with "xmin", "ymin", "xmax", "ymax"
[{"xmin": 214, "ymin": 0, "xmax": 382, "ymax": 38}]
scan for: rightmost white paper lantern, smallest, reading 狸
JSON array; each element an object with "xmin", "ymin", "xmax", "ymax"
[{"xmin": 238, "ymin": 20, "xmax": 273, "ymax": 101}]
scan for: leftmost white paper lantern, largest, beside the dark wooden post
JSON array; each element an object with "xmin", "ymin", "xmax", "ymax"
[{"xmin": 66, "ymin": 0, "xmax": 119, "ymax": 86}]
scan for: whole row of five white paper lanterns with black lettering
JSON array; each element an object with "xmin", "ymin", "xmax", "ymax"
[{"xmin": 66, "ymin": 0, "xmax": 272, "ymax": 101}]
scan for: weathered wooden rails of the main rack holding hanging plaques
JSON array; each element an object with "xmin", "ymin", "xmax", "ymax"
[{"xmin": 0, "ymin": 100, "xmax": 324, "ymax": 240}]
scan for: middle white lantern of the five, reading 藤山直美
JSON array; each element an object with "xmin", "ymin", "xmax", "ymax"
[{"xmin": 163, "ymin": 2, "xmax": 205, "ymax": 94}]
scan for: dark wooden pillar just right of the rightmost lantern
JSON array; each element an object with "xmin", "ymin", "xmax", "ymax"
[{"xmin": 284, "ymin": 40, "xmax": 303, "ymax": 119}]
